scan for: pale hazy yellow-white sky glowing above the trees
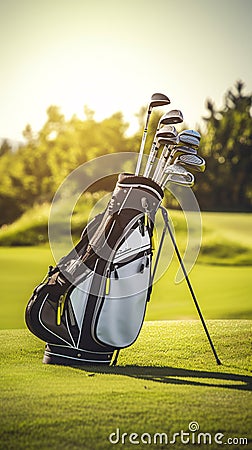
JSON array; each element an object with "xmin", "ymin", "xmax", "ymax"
[{"xmin": 0, "ymin": 0, "xmax": 252, "ymax": 140}]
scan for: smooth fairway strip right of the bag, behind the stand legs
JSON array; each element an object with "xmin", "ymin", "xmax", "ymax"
[{"xmin": 150, "ymin": 261, "xmax": 252, "ymax": 320}]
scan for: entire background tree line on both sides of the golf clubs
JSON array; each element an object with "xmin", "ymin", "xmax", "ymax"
[{"xmin": 0, "ymin": 81, "xmax": 252, "ymax": 226}]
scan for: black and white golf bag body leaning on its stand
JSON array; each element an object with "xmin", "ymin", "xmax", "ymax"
[{"xmin": 25, "ymin": 174, "xmax": 163, "ymax": 366}]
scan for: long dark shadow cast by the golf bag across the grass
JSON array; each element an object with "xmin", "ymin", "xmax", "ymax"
[{"xmin": 74, "ymin": 366, "xmax": 252, "ymax": 391}]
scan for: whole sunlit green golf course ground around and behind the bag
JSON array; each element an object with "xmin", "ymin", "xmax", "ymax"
[{"xmin": 0, "ymin": 212, "xmax": 252, "ymax": 450}]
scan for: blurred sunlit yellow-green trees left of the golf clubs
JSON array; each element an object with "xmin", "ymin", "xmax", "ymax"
[{"xmin": 0, "ymin": 105, "xmax": 136, "ymax": 226}]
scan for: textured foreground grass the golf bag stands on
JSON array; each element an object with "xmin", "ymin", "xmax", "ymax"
[{"xmin": 0, "ymin": 320, "xmax": 252, "ymax": 450}]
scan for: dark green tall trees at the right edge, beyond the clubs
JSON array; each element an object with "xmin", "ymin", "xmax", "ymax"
[{"xmin": 197, "ymin": 81, "xmax": 252, "ymax": 211}]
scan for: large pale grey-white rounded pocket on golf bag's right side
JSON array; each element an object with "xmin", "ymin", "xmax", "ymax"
[{"xmin": 94, "ymin": 254, "xmax": 150, "ymax": 348}]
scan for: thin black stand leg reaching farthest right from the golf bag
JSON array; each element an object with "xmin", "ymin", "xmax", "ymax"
[{"xmin": 160, "ymin": 206, "xmax": 221, "ymax": 365}]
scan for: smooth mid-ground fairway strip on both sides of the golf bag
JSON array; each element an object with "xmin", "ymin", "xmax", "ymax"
[{"xmin": 0, "ymin": 247, "xmax": 252, "ymax": 329}]
